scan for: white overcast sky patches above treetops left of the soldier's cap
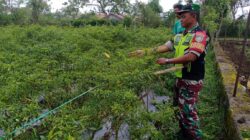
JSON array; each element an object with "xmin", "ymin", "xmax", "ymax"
[{"xmin": 49, "ymin": 0, "xmax": 178, "ymax": 12}]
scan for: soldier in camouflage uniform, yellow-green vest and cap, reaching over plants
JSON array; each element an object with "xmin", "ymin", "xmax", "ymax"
[{"xmin": 157, "ymin": 4, "xmax": 209, "ymax": 140}]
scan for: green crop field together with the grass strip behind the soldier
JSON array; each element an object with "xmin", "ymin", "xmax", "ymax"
[{"xmin": 0, "ymin": 25, "xmax": 224, "ymax": 140}]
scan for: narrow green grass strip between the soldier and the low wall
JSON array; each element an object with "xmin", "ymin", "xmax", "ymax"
[{"xmin": 198, "ymin": 46, "xmax": 227, "ymax": 140}]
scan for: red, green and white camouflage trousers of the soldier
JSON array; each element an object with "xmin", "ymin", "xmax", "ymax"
[{"xmin": 176, "ymin": 79, "xmax": 203, "ymax": 140}]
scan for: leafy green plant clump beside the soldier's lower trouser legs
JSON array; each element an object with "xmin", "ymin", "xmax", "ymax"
[{"xmin": 129, "ymin": 104, "xmax": 178, "ymax": 140}]
